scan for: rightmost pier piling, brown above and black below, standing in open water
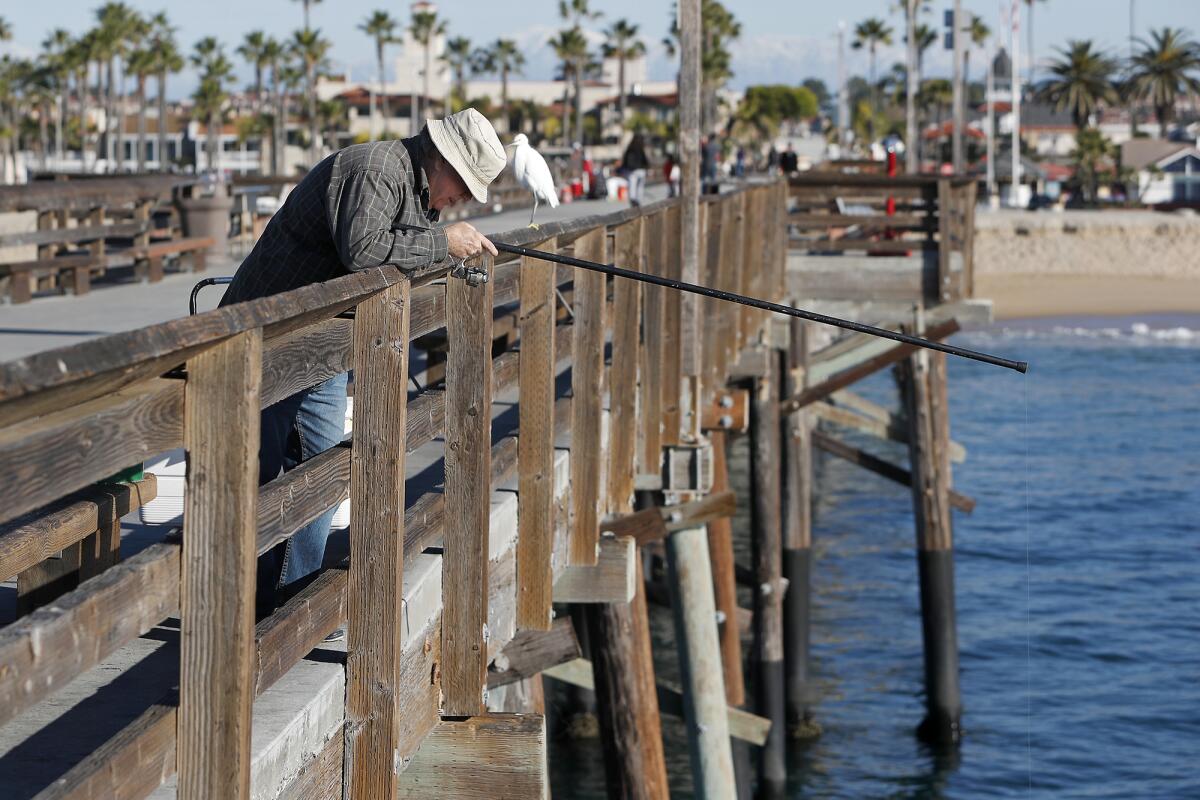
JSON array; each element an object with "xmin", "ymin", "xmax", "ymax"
[{"xmin": 899, "ymin": 326, "xmax": 962, "ymax": 744}]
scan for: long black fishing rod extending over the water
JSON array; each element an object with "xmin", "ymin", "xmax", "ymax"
[{"xmin": 492, "ymin": 239, "xmax": 1030, "ymax": 374}]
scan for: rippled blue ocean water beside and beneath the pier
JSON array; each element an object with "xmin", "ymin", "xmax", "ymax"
[{"xmin": 552, "ymin": 317, "xmax": 1200, "ymax": 799}]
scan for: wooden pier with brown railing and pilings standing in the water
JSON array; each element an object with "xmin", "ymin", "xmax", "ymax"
[{"xmin": 0, "ymin": 167, "xmax": 986, "ymax": 799}]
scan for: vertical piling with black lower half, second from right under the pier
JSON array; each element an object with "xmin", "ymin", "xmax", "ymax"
[{"xmin": 780, "ymin": 319, "xmax": 821, "ymax": 739}]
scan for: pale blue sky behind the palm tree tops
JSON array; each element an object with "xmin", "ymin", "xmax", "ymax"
[{"xmin": 0, "ymin": 0, "xmax": 1200, "ymax": 94}]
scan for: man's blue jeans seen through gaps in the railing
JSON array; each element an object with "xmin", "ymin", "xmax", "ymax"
[{"xmin": 258, "ymin": 373, "xmax": 347, "ymax": 615}]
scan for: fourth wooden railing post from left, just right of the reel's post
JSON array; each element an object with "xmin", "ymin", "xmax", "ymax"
[{"xmin": 516, "ymin": 240, "xmax": 557, "ymax": 631}]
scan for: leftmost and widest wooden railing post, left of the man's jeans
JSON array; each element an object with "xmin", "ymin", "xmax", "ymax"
[{"xmin": 176, "ymin": 329, "xmax": 263, "ymax": 800}]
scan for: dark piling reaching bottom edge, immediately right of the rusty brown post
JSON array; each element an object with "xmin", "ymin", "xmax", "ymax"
[{"xmin": 750, "ymin": 354, "xmax": 787, "ymax": 799}]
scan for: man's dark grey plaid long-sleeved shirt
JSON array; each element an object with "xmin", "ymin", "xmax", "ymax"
[{"xmin": 221, "ymin": 130, "xmax": 446, "ymax": 306}]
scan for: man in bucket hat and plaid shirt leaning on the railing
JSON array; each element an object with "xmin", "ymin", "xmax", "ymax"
[{"xmin": 221, "ymin": 108, "xmax": 505, "ymax": 640}]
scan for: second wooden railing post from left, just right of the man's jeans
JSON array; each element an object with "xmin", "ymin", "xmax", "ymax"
[{"xmin": 344, "ymin": 279, "xmax": 410, "ymax": 800}]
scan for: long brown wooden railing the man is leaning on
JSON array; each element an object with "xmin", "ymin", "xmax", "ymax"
[{"xmin": 0, "ymin": 182, "xmax": 785, "ymax": 798}]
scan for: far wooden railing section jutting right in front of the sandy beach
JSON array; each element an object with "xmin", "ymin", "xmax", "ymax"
[{"xmin": 788, "ymin": 172, "xmax": 977, "ymax": 302}]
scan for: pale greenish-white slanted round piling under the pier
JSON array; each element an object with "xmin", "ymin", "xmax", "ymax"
[{"xmin": 666, "ymin": 528, "xmax": 737, "ymax": 800}]
